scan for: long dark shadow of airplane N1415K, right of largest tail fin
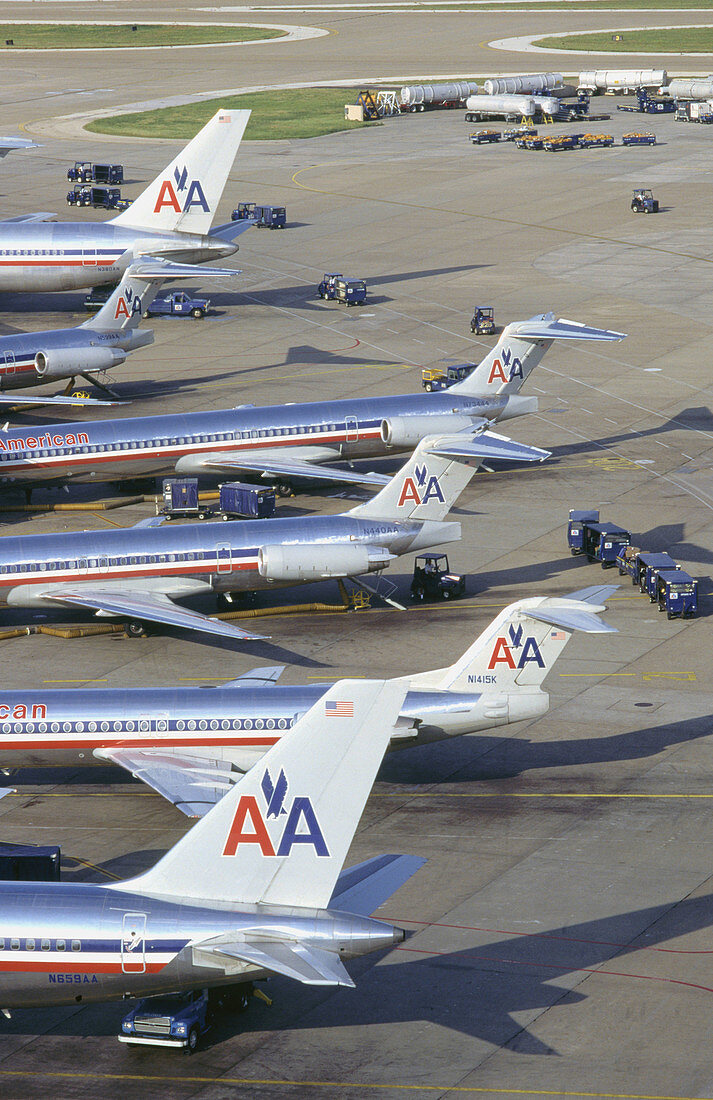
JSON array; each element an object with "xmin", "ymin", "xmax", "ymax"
[{"xmin": 379, "ymin": 715, "xmax": 713, "ymax": 799}]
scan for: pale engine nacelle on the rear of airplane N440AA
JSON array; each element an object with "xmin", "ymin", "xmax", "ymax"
[{"xmin": 257, "ymin": 542, "xmax": 395, "ymax": 581}]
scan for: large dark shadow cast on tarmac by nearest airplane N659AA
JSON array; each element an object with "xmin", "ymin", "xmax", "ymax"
[{"xmin": 1, "ymin": 884, "xmax": 713, "ymax": 1047}]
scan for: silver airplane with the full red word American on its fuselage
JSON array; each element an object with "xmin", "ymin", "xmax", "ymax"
[{"xmin": 0, "ymin": 314, "xmax": 624, "ymax": 488}]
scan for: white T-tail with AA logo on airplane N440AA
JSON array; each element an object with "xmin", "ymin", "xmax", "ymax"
[{"xmin": 349, "ymin": 431, "xmax": 550, "ymax": 520}]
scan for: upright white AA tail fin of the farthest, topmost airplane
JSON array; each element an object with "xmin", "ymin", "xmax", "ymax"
[{"xmin": 112, "ymin": 110, "xmax": 250, "ymax": 233}]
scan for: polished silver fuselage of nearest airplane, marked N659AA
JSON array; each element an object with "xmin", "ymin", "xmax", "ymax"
[{"xmin": 0, "ymin": 882, "xmax": 403, "ymax": 1008}]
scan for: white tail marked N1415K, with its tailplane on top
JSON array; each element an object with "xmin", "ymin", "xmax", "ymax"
[{"xmin": 403, "ymin": 596, "xmax": 614, "ymax": 692}]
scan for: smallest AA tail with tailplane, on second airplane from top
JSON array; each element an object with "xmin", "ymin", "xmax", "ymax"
[{"xmin": 79, "ymin": 260, "xmax": 240, "ymax": 332}]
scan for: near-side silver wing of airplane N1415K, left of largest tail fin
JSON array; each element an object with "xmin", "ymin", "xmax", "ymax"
[{"xmin": 94, "ymin": 747, "xmax": 243, "ymax": 817}]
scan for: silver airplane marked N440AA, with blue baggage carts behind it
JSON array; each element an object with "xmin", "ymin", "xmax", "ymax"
[{"xmin": 0, "ymin": 424, "xmax": 549, "ymax": 639}]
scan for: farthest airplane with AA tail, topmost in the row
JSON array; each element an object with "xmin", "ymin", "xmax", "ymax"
[{"xmin": 0, "ymin": 110, "xmax": 253, "ymax": 292}]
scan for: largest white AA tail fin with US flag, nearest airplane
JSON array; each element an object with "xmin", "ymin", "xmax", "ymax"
[{"xmin": 118, "ymin": 680, "xmax": 406, "ymax": 909}]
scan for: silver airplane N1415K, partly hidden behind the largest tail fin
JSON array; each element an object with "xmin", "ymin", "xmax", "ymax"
[{"xmin": 0, "ymin": 585, "xmax": 616, "ymax": 817}]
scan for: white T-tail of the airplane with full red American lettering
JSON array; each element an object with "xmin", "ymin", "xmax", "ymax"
[{"xmin": 450, "ymin": 314, "xmax": 626, "ymax": 397}]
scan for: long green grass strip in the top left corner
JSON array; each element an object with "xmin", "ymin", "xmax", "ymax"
[{"xmin": 0, "ymin": 23, "xmax": 286, "ymax": 51}]
